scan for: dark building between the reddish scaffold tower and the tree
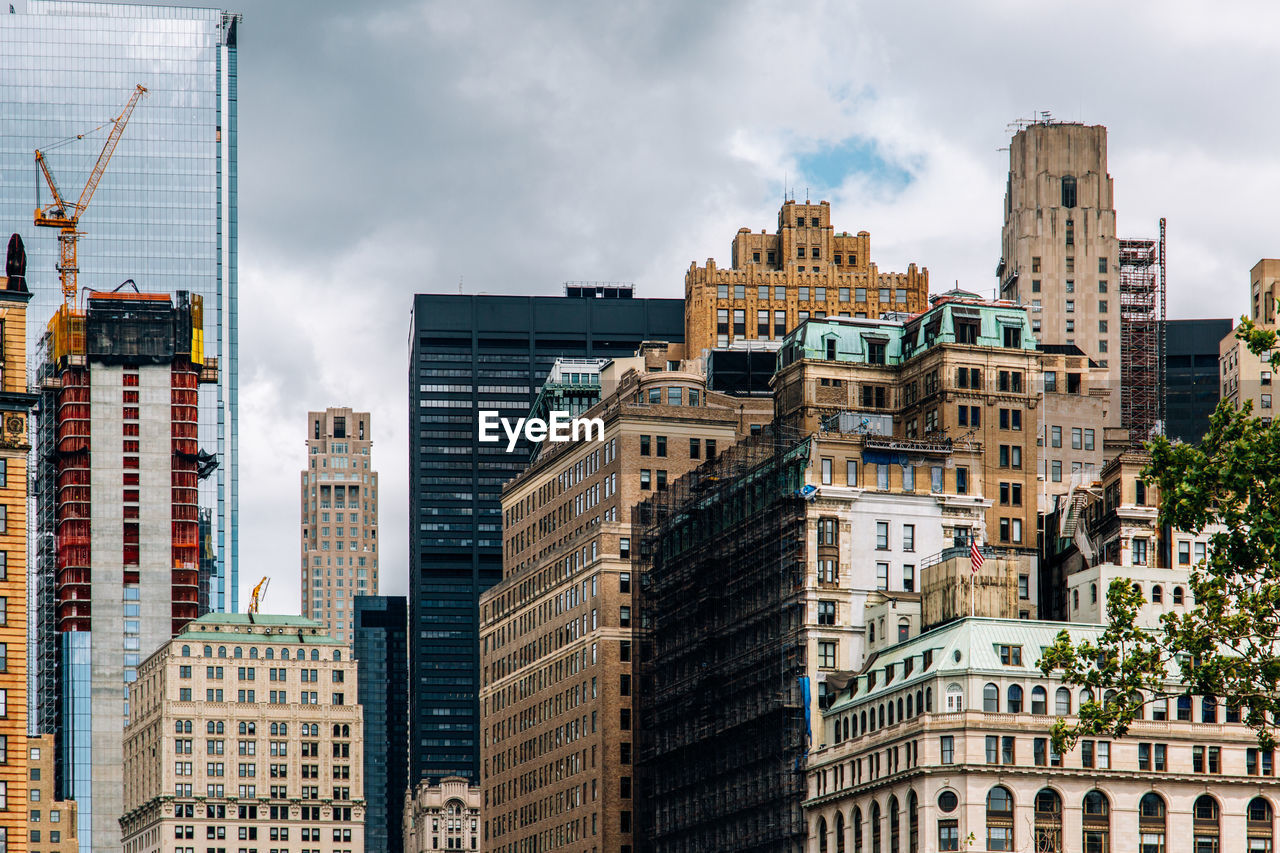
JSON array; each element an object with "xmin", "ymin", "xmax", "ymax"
[{"xmin": 1165, "ymin": 319, "xmax": 1231, "ymax": 443}]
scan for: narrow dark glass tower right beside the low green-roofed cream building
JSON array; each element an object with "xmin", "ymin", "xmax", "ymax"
[{"xmin": 353, "ymin": 596, "xmax": 408, "ymax": 853}]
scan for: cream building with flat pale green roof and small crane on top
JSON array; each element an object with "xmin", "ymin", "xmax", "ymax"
[{"xmin": 120, "ymin": 613, "xmax": 365, "ymax": 853}]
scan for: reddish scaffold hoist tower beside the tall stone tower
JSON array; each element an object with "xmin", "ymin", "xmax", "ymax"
[{"xmin": 1119, "ymin": 219, "xmax": 1165, "ymax": 444}]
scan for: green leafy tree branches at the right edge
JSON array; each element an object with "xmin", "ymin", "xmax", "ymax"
[{"xmin": 1039, "ymin": 318, "xmax": 1280, "ymax": 753}]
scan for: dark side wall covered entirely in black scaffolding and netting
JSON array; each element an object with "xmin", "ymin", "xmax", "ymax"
[{"xmin": 634, "ymin": 434, "xmax": 810, "ymax": 853}]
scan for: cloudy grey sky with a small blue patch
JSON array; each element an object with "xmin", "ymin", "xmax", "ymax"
[{"xmin": 225, "ymin": 0, "xmax": 1280, "ymax": 612}]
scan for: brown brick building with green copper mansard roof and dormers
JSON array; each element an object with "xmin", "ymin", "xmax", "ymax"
[{"xmin": 773, "ymin": 291, "xmax": 1041, "ymax": 558}]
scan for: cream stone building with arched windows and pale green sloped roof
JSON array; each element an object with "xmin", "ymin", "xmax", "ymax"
[{"xmin": 805, "ymin": 619, "xmax": 1275, "ymax": 853}]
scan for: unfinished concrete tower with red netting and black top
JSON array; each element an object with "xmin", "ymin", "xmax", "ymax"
[{"xmin": 36, "ymin": 286, "xmax": 218, "ymax": 839}]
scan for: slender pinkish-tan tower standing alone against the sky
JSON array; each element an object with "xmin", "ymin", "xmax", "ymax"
[{"xmin": 301, "ymin": 409, "xmax": 378, "ymax": 643}]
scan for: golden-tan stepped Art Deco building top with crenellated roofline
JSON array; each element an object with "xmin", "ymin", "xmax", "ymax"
[{"xmin": 685, "ymin": 201, "xmax": 929, "ymax": 356}]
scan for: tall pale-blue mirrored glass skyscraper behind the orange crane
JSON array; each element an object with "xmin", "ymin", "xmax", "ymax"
[{"xmin": 0, "ymin": 0, "xmax": 239, "ymax": 611}]
